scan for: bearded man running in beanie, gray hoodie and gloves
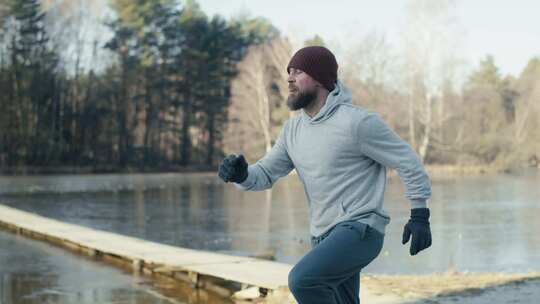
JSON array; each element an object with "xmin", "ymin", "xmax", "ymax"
[{"xmin": 219, "ymin": 46, "xmax": 431, "ymax": 304}]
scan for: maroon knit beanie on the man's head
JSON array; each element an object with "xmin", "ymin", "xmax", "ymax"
[{"xmin": 287, "ymin": 46, "xmax": 338, "ymax": 91}]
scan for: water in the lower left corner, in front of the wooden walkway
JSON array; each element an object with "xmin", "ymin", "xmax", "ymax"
[{"xmin": 0, "ymin": 230, "xmax": 228, "ymax": 304}]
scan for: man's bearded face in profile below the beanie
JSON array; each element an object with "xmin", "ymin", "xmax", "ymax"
[{"xmin": 287, "ymin": 68, "xmax": 317, "ymax": 111}]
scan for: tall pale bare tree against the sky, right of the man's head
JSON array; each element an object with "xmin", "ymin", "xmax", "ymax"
[{"xmin": 403, "ymin": 0, "xmax": 459, "ymax": 160}]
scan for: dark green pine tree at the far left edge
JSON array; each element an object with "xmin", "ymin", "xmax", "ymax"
[{"xmin": 7, "ymin": 0, "xmax": 58, "ymax": 164}]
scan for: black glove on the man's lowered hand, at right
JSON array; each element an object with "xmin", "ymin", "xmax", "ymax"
[{"xmin": 402, "ymin": 208, "xmax": 431, "ymax": 255}]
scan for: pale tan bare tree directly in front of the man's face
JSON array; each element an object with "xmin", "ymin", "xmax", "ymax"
[{"xmin": 226, "ymin": 39, "xmax": 291, "ymax": 157}]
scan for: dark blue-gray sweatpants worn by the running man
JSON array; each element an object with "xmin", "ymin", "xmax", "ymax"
[{"xmin": 289, "ymin": 221, "xmax": 384, "ymax": 304}]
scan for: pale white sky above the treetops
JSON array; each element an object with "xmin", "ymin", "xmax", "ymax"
[{"xmin": 197, "ymin": 0, "xmax": 540, "ymax": 76}]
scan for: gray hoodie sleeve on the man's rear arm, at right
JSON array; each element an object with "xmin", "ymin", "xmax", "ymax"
[{"xmin": 357, "ymin": 113, "xmax": 431, "ymax": 208}]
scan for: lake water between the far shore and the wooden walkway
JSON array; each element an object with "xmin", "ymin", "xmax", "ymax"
[{"xmin": 0, "ymin": 172, "xmax": 540, "ymax": 273}]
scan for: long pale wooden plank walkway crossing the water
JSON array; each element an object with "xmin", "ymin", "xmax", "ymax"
[{"xmin": 0, "ymin": 205, "xmax": 292, "ymax": 290}]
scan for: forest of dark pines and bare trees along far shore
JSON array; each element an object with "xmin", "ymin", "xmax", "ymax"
[{"xmin": 0, "ymin": 0, "xmax": 540, "ymax": 173}]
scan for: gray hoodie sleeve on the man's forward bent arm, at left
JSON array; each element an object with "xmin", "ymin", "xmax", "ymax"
[{"xmin": 235, "ymin": 123, "xmax": 294, "ymax": 191}]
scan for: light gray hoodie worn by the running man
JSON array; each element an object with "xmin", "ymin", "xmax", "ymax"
[{"xmin": 236, "ymin": 81, "xmax": 431, "ymax": 237}]
